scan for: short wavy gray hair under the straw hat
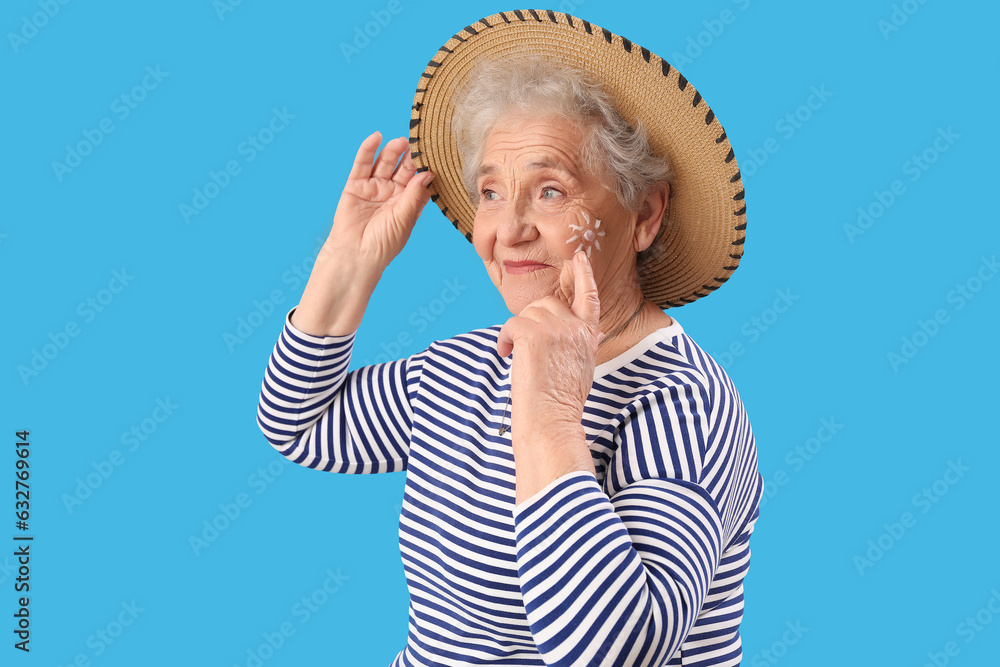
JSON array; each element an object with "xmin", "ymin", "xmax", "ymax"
[{"xmin": 452, "ymin": 53, "xmax": 671, "ymax": 278}]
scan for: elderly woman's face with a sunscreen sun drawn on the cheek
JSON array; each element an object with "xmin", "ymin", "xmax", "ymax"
[{"xmin": 472, "ymin": 117, "xmax": 637, "ymax": 315}]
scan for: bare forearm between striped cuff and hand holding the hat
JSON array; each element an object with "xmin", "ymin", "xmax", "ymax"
[{"xmin": 292, "ymin": 240, "xmax": 382, "ymax": 336}]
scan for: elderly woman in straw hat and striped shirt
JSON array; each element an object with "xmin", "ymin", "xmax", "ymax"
[{"xmin": 258, "ymin": 11, "xmax": 761, "ymax": 666}]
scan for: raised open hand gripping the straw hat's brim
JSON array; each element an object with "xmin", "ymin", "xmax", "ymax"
[{"xmin": 329, "ymin": 132, "xmax": 433, "ymax": 272}]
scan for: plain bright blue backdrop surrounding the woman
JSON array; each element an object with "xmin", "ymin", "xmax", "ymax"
[{"xmin": 0, "ymin": 0, "xmax": 1000, "ymax": 667}]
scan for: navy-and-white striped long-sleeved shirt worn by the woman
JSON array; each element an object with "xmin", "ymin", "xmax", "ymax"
[{"xmin": 257, "ymin": 308, "xmax": 762, "ymax": 667}]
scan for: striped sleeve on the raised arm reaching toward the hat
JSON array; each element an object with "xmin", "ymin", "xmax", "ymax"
[{"xmin": 257, "ymin": 308, "xmax": 421, "ymax": 473}]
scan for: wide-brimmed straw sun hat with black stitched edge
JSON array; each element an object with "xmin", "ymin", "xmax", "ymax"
[{"xmin": 410, "ymin": 9, "xmax": 746, "ymax": 308}]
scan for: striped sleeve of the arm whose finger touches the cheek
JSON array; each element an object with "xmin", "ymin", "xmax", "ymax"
[{"xmin": 513, "ymin": 368, "xmax": 742, "ymax": 667}]
